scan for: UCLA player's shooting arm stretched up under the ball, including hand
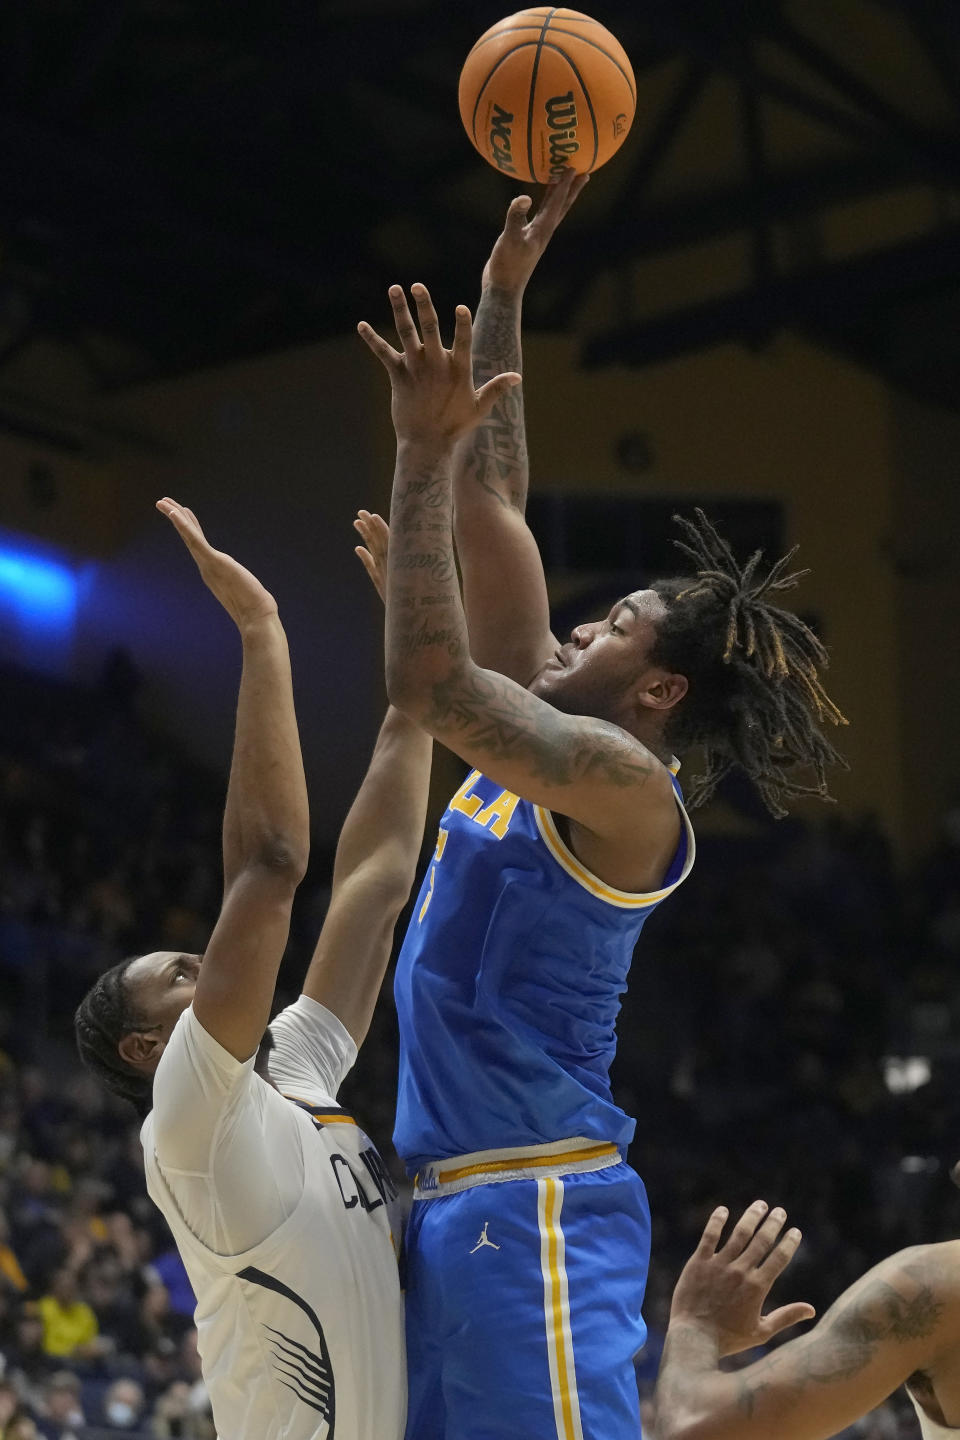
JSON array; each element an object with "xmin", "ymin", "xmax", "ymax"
[{"xmin": 453, "ymin": 170, "xmax": 590, "ymax": 685}]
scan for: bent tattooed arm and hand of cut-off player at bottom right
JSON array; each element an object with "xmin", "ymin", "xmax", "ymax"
[{"xmin": 656, "ymin": 1192, "xmax": 960, "ymax": 1440}]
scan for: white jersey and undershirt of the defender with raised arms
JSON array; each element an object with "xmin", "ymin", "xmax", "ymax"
[{"xmin": 141, "ymin": 996, "xmax": 406, "ymax": 1440}]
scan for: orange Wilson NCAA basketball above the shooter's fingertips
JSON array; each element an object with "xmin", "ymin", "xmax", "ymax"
[{"xmin": 461, "ymin": 6, "xmax": 636, "ymax": 181}]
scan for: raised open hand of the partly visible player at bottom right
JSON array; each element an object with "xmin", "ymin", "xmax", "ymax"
[{"xmin": 671, "ymin": 1200, "xmax": 816, "ymax": 1355}]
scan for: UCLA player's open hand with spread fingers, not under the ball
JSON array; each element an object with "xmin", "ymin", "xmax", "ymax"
[{"xmin": 357, "ymin": 277, "xmax": 520, "ymax": 449}]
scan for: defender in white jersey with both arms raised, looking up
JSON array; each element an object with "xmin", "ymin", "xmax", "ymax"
[{"xmin": 76, "ymin": 501, "xmax": 430, "ymax": 1440}]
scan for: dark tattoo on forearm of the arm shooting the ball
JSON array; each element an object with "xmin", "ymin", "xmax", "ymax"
[{"xmin": 466, "ymin": 285, "xmax": 527, "ymax": 513}]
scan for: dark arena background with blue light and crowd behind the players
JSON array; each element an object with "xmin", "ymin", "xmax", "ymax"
[{"xmin": 0, "ymin": 0, "xmax": 960, "ymax": 1440}]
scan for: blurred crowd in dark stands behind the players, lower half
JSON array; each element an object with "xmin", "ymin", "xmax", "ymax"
[{"xmin": 0, "ymin": 654, "xmax": 960, "ymax": 1440}]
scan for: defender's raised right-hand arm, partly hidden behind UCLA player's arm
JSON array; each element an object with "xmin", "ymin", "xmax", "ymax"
[{"xmin": 296, "ymin": 510, "xmax": 433, "ymax": 1045}]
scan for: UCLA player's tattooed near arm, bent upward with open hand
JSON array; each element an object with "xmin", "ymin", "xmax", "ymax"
[{"xmin": 360, "ymin": 285, "xmax": 682, "ymax": 852}]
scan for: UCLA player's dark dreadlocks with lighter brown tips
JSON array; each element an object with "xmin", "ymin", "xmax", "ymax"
[{"xmin": 651, "ymin": 510, "xmax": 848, "ymax": 818}]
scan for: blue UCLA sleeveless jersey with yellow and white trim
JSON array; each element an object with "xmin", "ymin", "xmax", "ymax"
[{"xmin": 393, "ymin": 770, "xmax": 694, "ymax": 1174}]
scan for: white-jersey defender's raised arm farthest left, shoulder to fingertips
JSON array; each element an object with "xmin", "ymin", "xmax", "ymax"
[{"xmin": 153, "ymin": 500, "xmax": 309, "ymax": 1060}]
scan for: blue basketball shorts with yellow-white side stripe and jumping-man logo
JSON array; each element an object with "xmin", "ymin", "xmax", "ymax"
[{"xmin": 406, "ymin": 1161, "xmax": 651, "ymax": 1440}]
